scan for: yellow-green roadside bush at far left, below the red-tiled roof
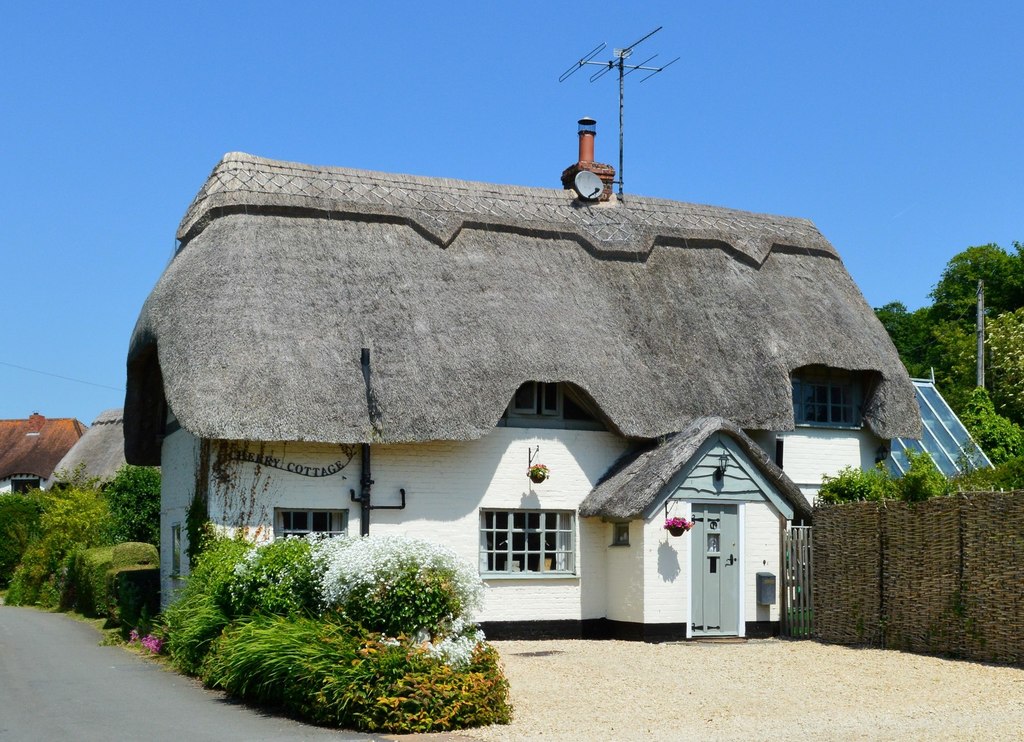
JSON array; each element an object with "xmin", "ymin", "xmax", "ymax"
[{"xmin": 6, "ymin": 486, "xmax": 108, "ymax": 608}]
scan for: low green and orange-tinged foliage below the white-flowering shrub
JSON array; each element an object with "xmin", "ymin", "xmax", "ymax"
[{"xmin": 203, "ymin": 616, "xmax": 512, "ymax": 733}]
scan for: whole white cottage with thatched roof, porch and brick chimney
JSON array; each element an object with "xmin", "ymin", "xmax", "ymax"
[{"xmin": 124, "ymin": 121, "xmax": 920, "ymax": 639}]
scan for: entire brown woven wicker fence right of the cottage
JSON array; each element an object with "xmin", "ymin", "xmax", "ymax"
[{"xmin": 813, "ymin": 492, "xmax": 1024, "ymax": 664}]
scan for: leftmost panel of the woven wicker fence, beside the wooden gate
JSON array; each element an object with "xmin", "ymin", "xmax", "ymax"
[{"xmin": 812, "ymin": 503, "xmax": 882, "ymax": 644}]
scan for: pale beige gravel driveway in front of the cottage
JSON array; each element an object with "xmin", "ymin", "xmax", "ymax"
[{"xmin": 460, "ymin": 640, "xmax": 1024, "ymax": 742}]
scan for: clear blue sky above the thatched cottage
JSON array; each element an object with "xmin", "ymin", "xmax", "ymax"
[{"xmin": 0, "ymin": 0, "xmax": 1024, "ymax": 424}]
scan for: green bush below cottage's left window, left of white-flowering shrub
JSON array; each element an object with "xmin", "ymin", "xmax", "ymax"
[{"xmin": 230, "ymin": 538, "xmax": 323, "ymax": 615}]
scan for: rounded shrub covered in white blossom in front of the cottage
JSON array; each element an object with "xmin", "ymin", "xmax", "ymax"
[{"xmin": 313, "ymin": 535, "xmax": 483, "ymax": 646}]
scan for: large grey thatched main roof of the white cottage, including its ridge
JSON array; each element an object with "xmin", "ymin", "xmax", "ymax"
[{"xmin": 125, "ymin": 155, "xmax": 919, "ymax": 464}]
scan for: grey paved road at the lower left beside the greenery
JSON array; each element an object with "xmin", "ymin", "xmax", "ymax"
[{"xmin": 0, "ymin": 606, "xmax": 389, "ymax": 742}]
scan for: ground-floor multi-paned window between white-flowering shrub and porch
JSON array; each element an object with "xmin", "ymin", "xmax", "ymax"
[{"xmin": 480, "ymin": 510, "xmax": 575, "ymax": 575}]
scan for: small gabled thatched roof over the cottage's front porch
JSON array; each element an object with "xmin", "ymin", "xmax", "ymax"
[{"xmin": 580, "ymin": 417, "xmax": 811, "ymax": 523}]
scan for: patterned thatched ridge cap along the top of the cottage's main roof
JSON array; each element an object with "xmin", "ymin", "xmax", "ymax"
[{"xmin": 177, "ymin": 152, "xmax": 839, "ymax": 264}]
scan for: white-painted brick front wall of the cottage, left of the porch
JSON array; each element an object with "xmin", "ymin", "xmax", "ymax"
[{"xmin": 192, "ymin": 428, "xmax": 627, "ymax": 621}]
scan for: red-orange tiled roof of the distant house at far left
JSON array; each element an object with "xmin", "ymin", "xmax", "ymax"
[{"xmin": 0, "ymin": 412, "xmax": 86, "ymax": 479}]
